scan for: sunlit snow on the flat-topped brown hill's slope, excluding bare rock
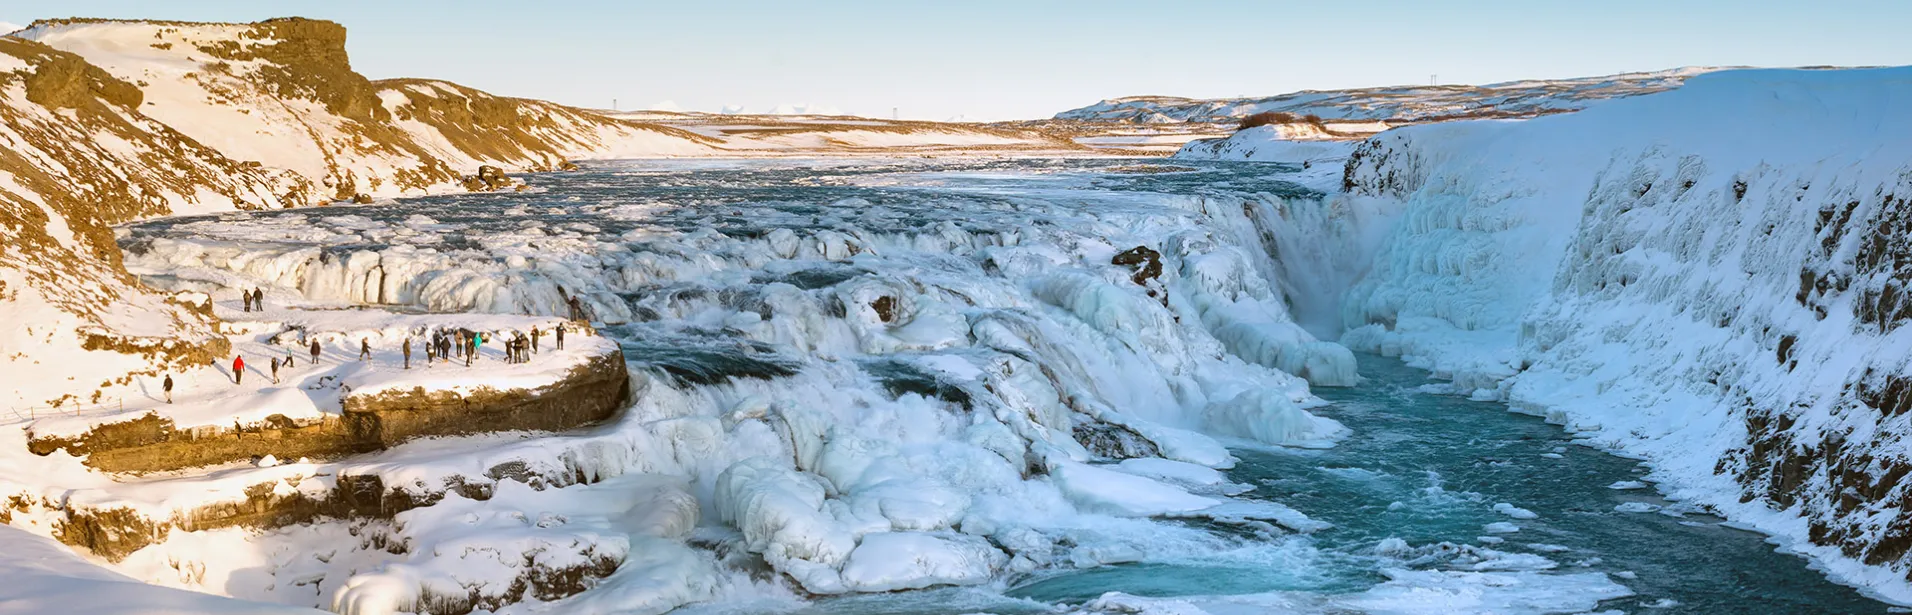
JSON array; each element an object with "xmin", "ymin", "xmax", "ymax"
[{"xmin": 17, "ymin": 21, "xmax": 711, "ymax": 204}]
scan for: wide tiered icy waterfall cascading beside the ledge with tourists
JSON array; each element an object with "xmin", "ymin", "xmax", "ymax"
[{"xmin": 44, "ymin": 162, "xmax": 1356, "ymax": 613}]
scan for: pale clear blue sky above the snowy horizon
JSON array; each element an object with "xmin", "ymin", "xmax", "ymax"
[{"xmin": 0, "ymin": 0, "xmax": 1912, "ymax": 120}]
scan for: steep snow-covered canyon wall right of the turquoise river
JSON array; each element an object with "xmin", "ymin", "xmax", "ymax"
[{"xmin": 1335, "ymin": 69, "xmax": 1912, "ymax": 602}]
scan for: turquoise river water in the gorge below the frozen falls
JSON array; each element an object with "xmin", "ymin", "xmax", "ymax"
[{"xmin": 1011, "ymin": 355, "xmax": 1887, "ymax": 615}]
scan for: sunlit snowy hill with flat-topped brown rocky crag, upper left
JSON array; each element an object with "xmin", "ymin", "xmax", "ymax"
[{"xmin": 11, "ymin": 17, "xmax": 707, "ymax": 204}]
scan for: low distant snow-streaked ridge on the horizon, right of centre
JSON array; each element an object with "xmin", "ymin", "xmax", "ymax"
[{"xmin": 1055, "ymin": 67, "xmax": 1719, "ymax": 124}]
